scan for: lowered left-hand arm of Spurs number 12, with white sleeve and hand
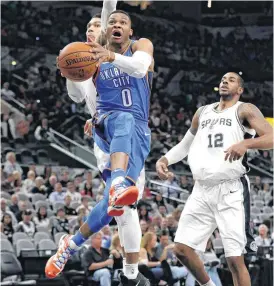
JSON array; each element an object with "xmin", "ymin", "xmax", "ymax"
[{"xmin": 156, "ymin": 107, "xmax": 203, "ymax": 180}]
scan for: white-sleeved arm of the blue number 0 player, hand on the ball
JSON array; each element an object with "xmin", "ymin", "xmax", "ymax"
[{"xmin": 86, "ymin": 38, "xmax": 153, "ymax": 78}]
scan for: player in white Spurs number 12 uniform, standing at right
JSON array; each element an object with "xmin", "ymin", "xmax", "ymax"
[{"xmin": 156, "ymin": 72, "xmax": 273, "ymax": 286}]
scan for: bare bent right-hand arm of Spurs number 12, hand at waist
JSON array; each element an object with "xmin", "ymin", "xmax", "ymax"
[{"xmin": 225, "ymin": 103, "xmax": 274, "ymax": 162}]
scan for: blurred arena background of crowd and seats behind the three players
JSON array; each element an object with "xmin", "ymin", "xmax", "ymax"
[{"xmin": 0, "ymin": 1, "xmax": 274, "ymax": 286}]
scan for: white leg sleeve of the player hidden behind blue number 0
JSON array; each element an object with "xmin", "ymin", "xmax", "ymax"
[{"xmin": 116, "ymin": 207, "xmax": 142, "ymax": 253}]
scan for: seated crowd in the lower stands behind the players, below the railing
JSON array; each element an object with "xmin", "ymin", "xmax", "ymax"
[{"xmin": 1, "ymin": 156, "xmax": 274, "ymax": 286}]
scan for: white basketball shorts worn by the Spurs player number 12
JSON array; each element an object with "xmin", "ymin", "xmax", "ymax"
[{"xmin": 174, "ymin": 176, "xmax": 257, "ymax": 257}]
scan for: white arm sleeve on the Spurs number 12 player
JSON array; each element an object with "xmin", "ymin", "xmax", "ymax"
[{"xmin": 165, "ymin": 130, "xmax": 195, "ymax": 165}]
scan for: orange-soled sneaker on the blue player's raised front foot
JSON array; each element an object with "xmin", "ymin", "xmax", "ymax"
[{"xmin": 108, "ymin": 182, "xmax": 139, "ymax": 216}]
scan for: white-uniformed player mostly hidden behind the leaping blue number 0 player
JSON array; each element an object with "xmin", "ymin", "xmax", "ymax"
[{"xmin": 63, "ymin": 0, "xmax": 147, "ymax": 285}]
